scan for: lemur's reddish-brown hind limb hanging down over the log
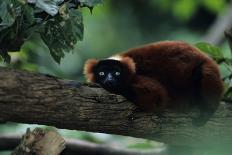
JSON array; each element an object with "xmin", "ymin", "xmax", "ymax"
[{"xmin": 193, "ymin": 61, "xmax": 223, "ymax": 126}]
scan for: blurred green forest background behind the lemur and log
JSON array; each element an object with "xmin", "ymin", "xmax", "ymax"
[{"xmin": 0, "ymin": 0, "xmax": 232, "ymax": 155}]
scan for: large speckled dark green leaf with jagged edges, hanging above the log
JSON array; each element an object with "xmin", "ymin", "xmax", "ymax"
[{"xmin": 41, "ymin": 6, "xmax": 84, "ymax": 63}]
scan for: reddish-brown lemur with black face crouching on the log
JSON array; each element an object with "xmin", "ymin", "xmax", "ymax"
[{"xmin": 84, "ymin": 41, "xmax": 223, "ymax": 125}]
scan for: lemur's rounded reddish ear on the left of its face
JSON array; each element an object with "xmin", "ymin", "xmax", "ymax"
[{"xmin": 84, "ymin": 59, "xmax": 98, "ymax": 82}]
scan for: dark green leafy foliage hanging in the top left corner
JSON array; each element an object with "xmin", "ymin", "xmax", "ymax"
[{"xmin": 0, "ymin": 0, "xmax": 102, "ymax": 63}]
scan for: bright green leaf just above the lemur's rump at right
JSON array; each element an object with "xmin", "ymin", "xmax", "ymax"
[{"xmin": 195, "ymin": 42, "xmax": 225, "ymax": 63}]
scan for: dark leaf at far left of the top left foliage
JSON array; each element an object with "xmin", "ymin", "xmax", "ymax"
[{"xmin": 0, "ymin": 0, "xmax": 34, "ymax": 54}]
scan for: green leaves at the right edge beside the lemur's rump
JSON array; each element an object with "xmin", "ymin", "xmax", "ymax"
[{"xmin": 196, "ymin": 42, "xmax": 232, "ymax": 100}]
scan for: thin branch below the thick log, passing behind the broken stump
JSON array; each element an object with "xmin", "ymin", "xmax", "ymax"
[{"xmin": 0, "ymin": 135, "xmax": 166, "ymax": 155}]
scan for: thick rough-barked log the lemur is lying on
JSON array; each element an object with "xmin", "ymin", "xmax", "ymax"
[{"xmin": 0, "ymin": 68, "xmax": 232, "ymax": 147}]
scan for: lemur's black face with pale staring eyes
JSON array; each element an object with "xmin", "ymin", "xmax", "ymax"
[{"xmin": 94, "ymin": 59, "xmax": 125, "ymax": 93}]
